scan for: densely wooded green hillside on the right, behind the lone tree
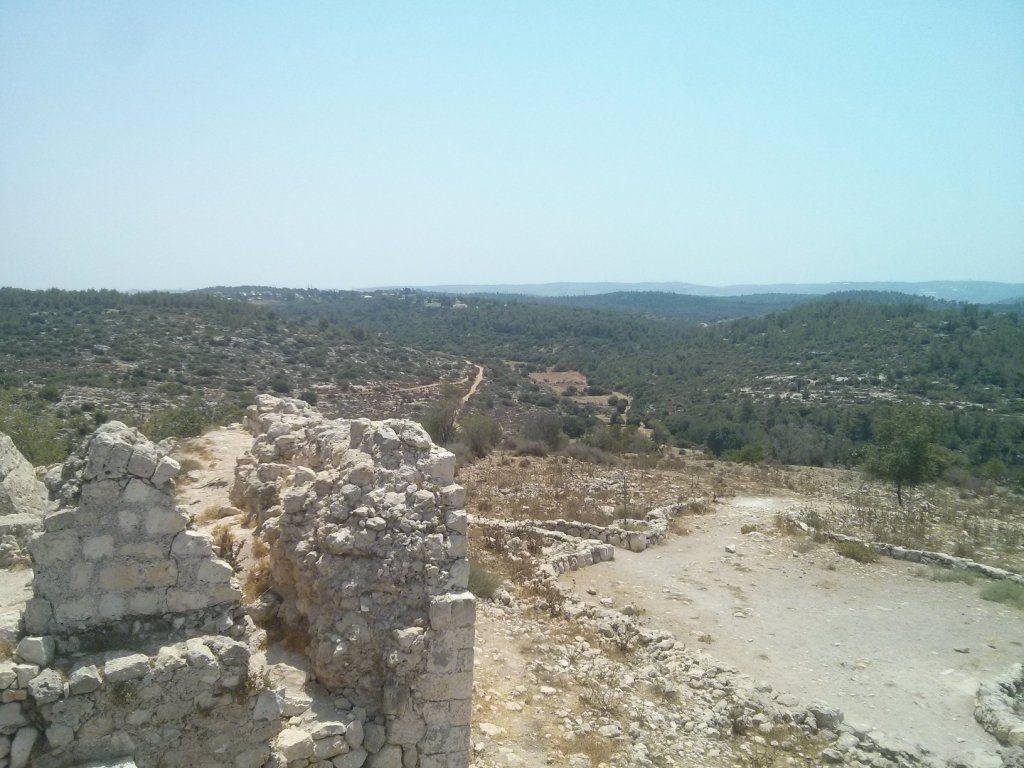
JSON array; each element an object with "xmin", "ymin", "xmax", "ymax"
[{"xmin": 201, "ymin": 289, "xmax": 1024, "ymax": 478}]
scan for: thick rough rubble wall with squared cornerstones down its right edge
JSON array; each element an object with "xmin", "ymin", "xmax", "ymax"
[{"xmin": 232, "ymin": 396, "xmax": 475, "ymax": 768}]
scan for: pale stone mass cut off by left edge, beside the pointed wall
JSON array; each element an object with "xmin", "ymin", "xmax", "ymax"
[{"xmin": 0, "ymin": 432, "xmax": 47, "ymax": 568}]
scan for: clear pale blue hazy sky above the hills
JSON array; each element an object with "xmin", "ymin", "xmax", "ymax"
[{"xmin": 0, "ymin": 0, "xmax": 1024, "ymax": 288}]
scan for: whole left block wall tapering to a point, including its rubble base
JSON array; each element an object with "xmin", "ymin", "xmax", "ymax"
[{"xmin": 0, "ymin": 422, "xmax": 266, "ymax": 768}]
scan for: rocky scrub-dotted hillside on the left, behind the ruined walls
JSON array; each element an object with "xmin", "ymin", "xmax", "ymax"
[{"xmin": 0, "ymin": 289, "xmax": 465, "ymax": 463}]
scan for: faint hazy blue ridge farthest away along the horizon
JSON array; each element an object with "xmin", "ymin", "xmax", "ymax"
[{"xmin": 397, "ymin": 281, "xmax": 1024, "ymax": 304}]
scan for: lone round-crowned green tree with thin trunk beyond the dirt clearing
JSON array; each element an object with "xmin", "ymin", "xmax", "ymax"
[{"xmin": 864, "ymin": 409, "xmax": 944, "ymax": 505}]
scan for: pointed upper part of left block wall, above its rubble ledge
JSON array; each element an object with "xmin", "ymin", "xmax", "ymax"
[{"xmin": 25, "ymin": 422, "xmax": 241, "ymax": 650}]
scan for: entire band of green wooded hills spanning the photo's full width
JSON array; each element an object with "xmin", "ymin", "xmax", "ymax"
[{"xmin": 6, "ymin": 287, "xmax": 1024, "ymax": 482}]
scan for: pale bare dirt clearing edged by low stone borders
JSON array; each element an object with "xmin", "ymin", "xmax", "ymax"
[{"xmin": 566, "ymin": 497, "xmax": 1024, "ymax": 757}]
